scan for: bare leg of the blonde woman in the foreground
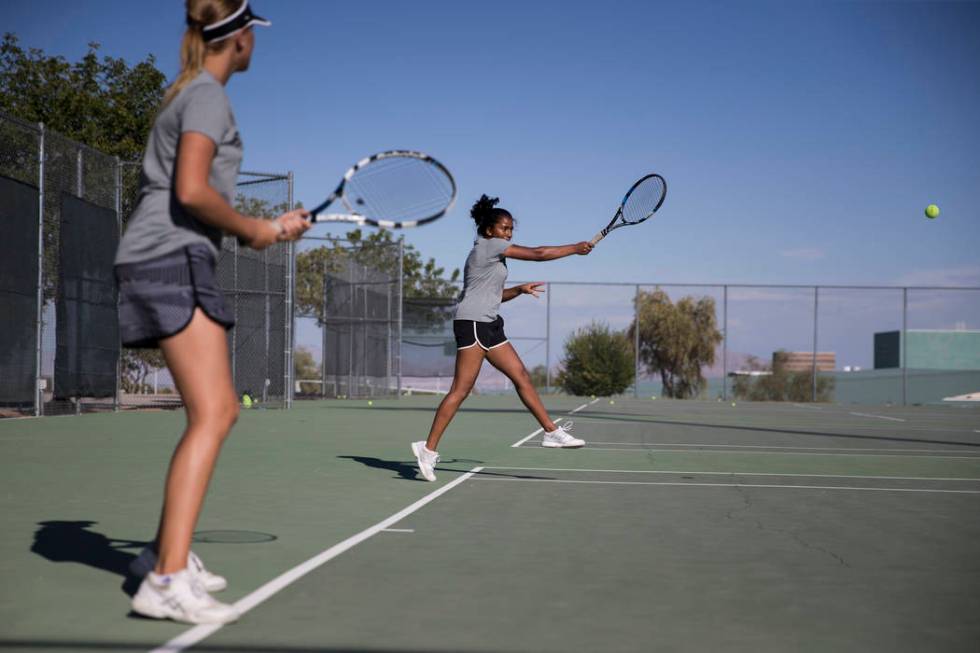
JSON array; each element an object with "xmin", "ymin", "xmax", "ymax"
[{"xmin": 156, "ymin": 307, "xmax": 238, "ymax": 574}]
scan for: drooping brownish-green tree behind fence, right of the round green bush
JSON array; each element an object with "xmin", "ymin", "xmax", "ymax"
[{"xmin": 626, "ymin": 288, "xmax": 722, "ymax": 399}]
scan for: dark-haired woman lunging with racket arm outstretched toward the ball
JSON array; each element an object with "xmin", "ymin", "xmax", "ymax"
[{"xmin": 412, "ymin": 195, "xmax": 592, "ymax": 481}]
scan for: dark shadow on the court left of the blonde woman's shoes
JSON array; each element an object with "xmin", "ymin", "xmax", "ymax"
[{"xmin": 31, "ymin": 520, "xmax": 148, "ymax": 596}]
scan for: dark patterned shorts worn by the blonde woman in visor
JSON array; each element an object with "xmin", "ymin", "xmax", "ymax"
[{"xmin": 116, "ymin": 245, "xmax": 235, "ymax": 348}]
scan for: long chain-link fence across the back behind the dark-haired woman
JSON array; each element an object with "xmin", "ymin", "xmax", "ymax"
[{"xmin": 403, "ymin": 282, "xmax": 980, "ymax": 404}]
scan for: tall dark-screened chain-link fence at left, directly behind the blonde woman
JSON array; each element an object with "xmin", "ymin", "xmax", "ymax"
[{"xmin": 0, "ymin": 106, "xmax": 292, "ymax": 415}]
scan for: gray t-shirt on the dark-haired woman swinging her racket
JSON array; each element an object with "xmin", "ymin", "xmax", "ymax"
[{"xmin": 456, "ymin": 236, "xmax": 510, "ymax": 322}]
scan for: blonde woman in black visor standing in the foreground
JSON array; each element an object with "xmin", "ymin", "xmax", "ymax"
[{"xmin": 116, "ymin": 0, "xmax": 309, "ymax": 623}]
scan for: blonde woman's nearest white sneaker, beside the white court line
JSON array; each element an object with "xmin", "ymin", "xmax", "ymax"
[{"xmin": 132, "ymin": 569, "xmax": 238, "ymax": 624}]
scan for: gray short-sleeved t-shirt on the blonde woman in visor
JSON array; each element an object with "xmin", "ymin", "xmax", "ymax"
[{"xmin": 116, "ymin": 71, "xmax": 242, "ymax": 263}]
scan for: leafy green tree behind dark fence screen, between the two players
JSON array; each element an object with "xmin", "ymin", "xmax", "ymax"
[{"xmin": 296, "ymin": 229, "xmax": 459, "ymax": 327}]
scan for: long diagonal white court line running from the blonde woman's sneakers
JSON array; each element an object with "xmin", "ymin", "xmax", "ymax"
[{"xmin": 150, "ymin": 467, "xmax": 483, "ymax": 653}]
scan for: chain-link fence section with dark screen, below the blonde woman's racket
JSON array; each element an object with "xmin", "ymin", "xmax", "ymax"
[{"xmin": 293, "ymin": 237, "xmax": 403, "ymax": 399}]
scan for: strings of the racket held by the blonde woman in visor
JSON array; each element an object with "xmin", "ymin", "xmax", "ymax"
[{"xmin": 344, "ymin": 158, "xmax": 454, "ymax": 221}]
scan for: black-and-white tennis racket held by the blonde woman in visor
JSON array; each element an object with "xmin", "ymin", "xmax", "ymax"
[{"xmin": 310, "ymin": 150, "xmax": 456, "ymax": 229}]
